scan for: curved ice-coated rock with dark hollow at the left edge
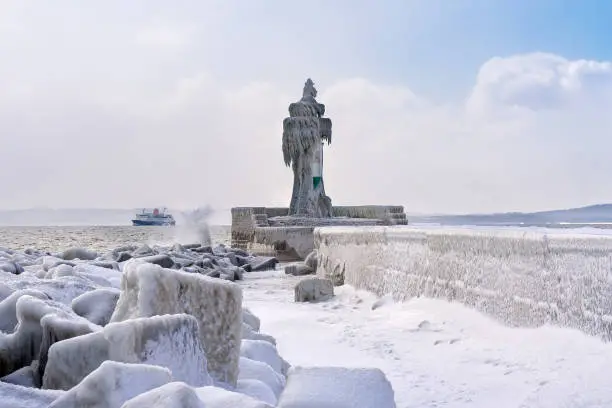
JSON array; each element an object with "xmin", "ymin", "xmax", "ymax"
[{"xmin": 0, "ymin": 295, "xmax": 95, "ymax": 376}]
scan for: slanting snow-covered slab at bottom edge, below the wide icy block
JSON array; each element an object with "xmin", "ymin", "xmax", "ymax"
[{"xmin": 49, "ymin": 361, "xmax": 172, "ymax": 408}]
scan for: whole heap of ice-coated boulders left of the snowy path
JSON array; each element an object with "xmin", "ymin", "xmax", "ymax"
[{"xmin": 0, "ymin": 243, "xmax": 396, "ymax": 408}]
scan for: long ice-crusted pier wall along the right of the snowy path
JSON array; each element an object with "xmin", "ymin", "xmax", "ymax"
[{"xmin": 315, "ymin": 227, "xmax": 612, "ymax": 340}]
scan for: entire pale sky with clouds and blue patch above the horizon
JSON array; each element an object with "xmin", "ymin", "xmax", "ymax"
[{"xmin": 0, "ymin": 0, "xmax": 612, "ymax": 217}]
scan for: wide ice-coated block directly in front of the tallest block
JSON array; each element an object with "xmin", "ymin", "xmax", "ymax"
[{"xmin": 43, "ymin": 314, "xmax": 212, "ymax": 390}]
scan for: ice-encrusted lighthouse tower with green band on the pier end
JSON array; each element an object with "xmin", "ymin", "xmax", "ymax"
[{"xmin": 283, "ymin": 78, "xmax": 332, "ymax": 218}]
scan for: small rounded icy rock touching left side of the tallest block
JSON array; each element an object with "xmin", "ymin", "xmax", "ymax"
[{"xmin": 72, "ymin": 288, "xmax": 121, "ymax": 326}]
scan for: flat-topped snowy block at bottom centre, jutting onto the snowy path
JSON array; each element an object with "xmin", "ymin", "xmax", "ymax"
[{"xmin": 278, "ymin": 367, "xmax": 395, "ymax": 408}]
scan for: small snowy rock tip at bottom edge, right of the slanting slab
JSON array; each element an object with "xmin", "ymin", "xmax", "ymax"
[{"xmin": 121, "ymin": 382, "xmax": 203, "ymax": 408}]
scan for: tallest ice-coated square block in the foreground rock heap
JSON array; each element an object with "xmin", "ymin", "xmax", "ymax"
[{"xmin": 111, "ymin": 260, "xmax": 242, "ymax": 385}]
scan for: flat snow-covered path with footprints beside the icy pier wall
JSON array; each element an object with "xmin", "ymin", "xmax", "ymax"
[{"xmin": 241, "ymin": 270, "xmax": 612, "ymax": 408}]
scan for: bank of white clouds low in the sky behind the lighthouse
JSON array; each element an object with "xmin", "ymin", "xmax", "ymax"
[{"xmin": 0, "ymin": 48, "xmax": 612, "ymax": 220}]
